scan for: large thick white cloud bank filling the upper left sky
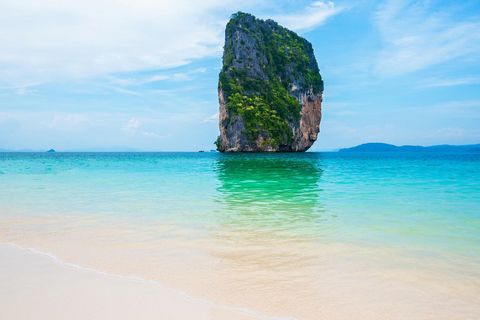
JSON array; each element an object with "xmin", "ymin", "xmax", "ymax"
[{"xmin": 0, "ymin": 0, "xmax": 248, "ymax": 82}]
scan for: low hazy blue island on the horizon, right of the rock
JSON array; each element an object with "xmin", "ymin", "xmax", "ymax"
[{"xmin": 338, "ymin": 142, "xmax": 480, "ymax": 153}]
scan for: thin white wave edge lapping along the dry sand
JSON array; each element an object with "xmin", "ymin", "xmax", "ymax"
[{"xmin": 0, "ymin": 242, "xmax": 300, "ymax": 320}]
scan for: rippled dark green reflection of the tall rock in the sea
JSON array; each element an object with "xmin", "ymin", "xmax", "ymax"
[{"xmin": 216, "ymin": 153, "xmax": 322, "ymax": 229}]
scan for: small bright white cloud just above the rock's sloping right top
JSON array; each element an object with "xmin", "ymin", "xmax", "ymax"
[{"xmin": 274, "ymin": 1, "xmax": 343, "ymax": 31}]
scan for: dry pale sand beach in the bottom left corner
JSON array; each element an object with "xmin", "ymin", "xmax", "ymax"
[{"xmin": 0, "ymin": 244, "xmax": 259, "ymax": 320}]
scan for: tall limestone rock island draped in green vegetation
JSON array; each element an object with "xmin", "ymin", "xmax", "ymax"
[{"xmin": 217, "ymin": 13, "xmax": 323, "ymax": 152}]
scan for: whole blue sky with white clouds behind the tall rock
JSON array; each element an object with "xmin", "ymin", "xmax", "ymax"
[{"xmin": 0, "ymin": 0, "xmax": 480, "ymax": 151}]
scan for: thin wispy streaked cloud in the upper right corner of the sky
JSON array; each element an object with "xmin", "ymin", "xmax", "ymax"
[{"xmin": 375, "ymin": 0, "xmax": 480, "ymax": 75}]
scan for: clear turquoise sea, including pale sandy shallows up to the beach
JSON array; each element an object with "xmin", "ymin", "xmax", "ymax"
[{"xmin": 0, "ymin": 152, "xmax": 480, "ymax": 319}]
